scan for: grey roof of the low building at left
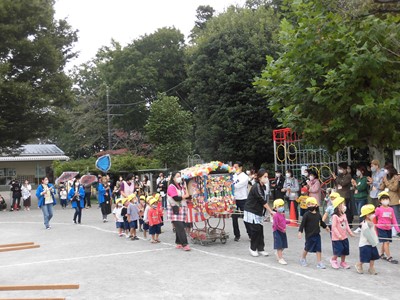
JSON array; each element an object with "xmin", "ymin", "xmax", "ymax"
[{"xmin": 0, "ymin": 144, "xmax": 69, "ymax": 162}]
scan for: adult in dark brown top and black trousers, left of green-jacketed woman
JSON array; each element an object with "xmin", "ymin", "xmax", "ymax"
[{"xmin": 332, "ymin": 162, "xmax": 354, "ymax": 228}]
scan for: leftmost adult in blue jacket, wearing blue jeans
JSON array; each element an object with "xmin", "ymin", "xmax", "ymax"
[{"xmin": 36, "ymin": 177, "xmax": 57, "ymax": 229}]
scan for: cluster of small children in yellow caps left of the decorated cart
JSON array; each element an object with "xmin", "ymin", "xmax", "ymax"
[{"xmin": 113, "ymin": 194, "xmax": 163, "ymax": 243}]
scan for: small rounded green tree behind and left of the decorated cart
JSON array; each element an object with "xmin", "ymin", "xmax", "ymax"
[{"xmin": 145, "ymin": 94, "xmax": 192, "ymax": 168}]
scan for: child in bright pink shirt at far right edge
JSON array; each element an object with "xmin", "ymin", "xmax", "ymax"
[{"xmin": 375, "ymin": 192, "xmax": 400, "ymax": 264}]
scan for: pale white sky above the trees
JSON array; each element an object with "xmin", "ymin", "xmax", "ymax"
[{"xmin": 54, "ymin": 0, "xmax": 246, "ymax": 69}]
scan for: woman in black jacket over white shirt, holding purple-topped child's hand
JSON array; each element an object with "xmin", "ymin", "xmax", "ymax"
[{"xmin": 243, "ymin": 169, "xmax": 273, "ymax": 256}]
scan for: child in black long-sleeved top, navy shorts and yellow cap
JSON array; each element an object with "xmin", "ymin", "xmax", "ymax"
[{"xmin": 298, "ymin": 197, "xmax": 330, "ymax": 269}]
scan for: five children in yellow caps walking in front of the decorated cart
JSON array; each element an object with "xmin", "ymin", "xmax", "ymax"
[{"xmin": 273, "ymin": 192, "xmax": 400, "ymax": 275}]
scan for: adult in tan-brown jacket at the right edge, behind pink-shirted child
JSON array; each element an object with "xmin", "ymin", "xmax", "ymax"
[{"xmin": 380, "ymin": 165, "xmax": 400, "ymax": 235}]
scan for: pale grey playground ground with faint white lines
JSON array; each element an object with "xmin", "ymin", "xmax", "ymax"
[{"xmin": 0, "ymin": 199, "xmax": 400, "ymax": 300}]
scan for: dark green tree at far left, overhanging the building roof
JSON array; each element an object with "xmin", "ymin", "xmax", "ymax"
[{"xmin": 0, "ymin": 0, "xmax": 77, "ymax": 149}]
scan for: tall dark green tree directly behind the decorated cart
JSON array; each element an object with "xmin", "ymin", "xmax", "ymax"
[{"xmin": 187, "ymin": 6, "xmax": 279, "ymax": 168}]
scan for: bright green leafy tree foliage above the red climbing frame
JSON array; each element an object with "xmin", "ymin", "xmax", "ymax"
[{"xmin": 256, "ymin": 0, "xmax": 400, "ymax": 161}]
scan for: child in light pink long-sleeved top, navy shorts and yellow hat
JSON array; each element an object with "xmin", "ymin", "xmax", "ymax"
[{"xmin": 330, "ymin": 197, "xmax": 354, "ymax": 269}]
